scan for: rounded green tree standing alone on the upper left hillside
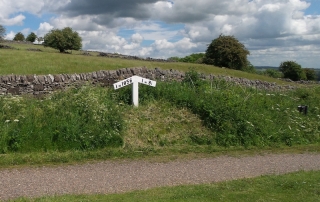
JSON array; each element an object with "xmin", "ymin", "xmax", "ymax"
[{"xmin": 43, "ymin": 27, "xmax": 82, "ymax": 53}]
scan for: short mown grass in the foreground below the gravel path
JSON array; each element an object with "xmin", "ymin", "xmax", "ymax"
[{"xmin": 11, "ymin": 171, "xmax": 320, "ymax": 202}]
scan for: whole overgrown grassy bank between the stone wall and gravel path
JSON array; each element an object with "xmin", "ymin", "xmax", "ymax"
[{"xmin": 0, "ymin": 77, "xmax": 320, "ymax": 167}]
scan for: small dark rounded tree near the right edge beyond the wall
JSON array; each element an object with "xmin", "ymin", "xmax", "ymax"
[{"xmin": 279, "ymin": 61, "xmax": 307, "ymax": 81}]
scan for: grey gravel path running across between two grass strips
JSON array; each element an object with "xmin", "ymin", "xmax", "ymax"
[{"xmin": 0, "ymin": 154, "xmax": 320, "ymax": 200}]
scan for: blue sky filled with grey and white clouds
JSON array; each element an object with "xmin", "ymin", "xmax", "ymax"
[{"xmin": 0, "ymin": 0, "xmax": 320, "ymax": 68}]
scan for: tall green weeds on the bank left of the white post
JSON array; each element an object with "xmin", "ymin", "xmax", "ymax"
[{"xmin": 0, "ymin": 86, "xmax": 124, "ymax": 153}]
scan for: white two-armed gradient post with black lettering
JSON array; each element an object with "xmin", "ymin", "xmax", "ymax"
[{"xmin": 113, "ymin": 76, "xmax": 157, "ymax": 107}]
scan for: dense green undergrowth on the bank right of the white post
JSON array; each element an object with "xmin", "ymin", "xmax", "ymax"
[{"xmin": 115, "ymin": 71, "xmax": 320, "ymax": 148}]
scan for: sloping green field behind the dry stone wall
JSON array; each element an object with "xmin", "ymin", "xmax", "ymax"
[{"xmin": 0, "ymin": 43, "xmax": 288, "ymax": 84}]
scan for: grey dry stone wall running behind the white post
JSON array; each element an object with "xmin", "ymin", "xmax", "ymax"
[{"xmin": 0, "ymin": 67, "xmax": 294, "ymax": 95}]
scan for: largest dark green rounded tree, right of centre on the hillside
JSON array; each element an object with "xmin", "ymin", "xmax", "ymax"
[{"xmin": 203, "ymin": 34, "xmax": 250, "ymax": 70}]
